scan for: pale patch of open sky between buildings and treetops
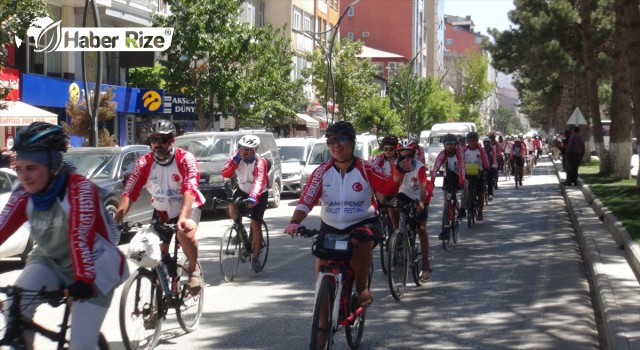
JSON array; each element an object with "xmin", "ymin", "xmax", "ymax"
[{"xmin": 444, "ymin": 0, "xmax": 514, "ymax": 35}]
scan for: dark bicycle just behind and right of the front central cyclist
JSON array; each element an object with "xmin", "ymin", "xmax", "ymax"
[{"xmin": 387, "ymin": 200, "xmax": 422, "ymax": 300}]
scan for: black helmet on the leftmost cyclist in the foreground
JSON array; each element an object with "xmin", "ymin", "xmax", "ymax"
[{"xmin": 11, "ymin": 122, "xmax": 69, "ymax": 152}]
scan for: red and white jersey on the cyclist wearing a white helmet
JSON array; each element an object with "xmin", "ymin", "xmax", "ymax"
[{"xmin": 222, "ymin": 154, "xmax": 269, "ymax": 199}]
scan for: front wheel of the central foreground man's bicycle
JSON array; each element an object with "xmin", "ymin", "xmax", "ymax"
[{"xmin": 309, "ymin": 278, "xmax": 336, "ymax": 350}]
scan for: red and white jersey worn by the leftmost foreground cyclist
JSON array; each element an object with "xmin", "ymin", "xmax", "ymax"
[{"xmin": 0, "ymin": 174, "xmax": 115, "ymax": 284}]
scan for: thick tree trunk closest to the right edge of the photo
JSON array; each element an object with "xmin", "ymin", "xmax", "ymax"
[{"xmin": 609, "ymin": 0, "xmax": 637, "ymax": 179}]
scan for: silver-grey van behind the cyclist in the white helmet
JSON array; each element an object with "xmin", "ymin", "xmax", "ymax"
[{"xmin": 175, "ymin": 130, "xmax": 282, "ymax": 210}]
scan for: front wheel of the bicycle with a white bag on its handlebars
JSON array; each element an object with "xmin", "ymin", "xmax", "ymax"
[{"xmin": 120, "ymin": 268, "xmax": 162, "ymax": 350}]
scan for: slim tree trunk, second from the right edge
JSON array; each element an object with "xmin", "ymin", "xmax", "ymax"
[{"xmin": 580, "ymin": 0, "xmax": 605, "ymax": 164}]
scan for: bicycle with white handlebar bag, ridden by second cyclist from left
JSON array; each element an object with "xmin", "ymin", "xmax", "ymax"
[{"xmin": 119, "ymin": 224, "xmax": 204, "ymax": 350}]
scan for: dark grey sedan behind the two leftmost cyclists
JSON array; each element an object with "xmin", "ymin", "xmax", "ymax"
[{"xmin": 64, "ymin": 145, "xmax": 153, "ymax": 227}]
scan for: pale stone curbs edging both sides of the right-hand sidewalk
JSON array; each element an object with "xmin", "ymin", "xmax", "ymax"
[{"xmin": 552, "ymin": 157, "xmax": 640, "ymax": 350}]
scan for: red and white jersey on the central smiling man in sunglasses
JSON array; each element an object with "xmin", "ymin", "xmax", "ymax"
[{"xmin": 296, "ymin": 158, "xmax": 399, "ymax": 229}]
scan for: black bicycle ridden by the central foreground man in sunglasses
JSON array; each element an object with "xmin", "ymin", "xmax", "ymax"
[{"xmin": 298, "ymin": 226, "xmax": 373, "ymax": 350}]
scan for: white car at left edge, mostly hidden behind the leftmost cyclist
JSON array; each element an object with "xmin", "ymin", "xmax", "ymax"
[{"xmin": 0, "ymin": 168, "xmax": 33, "ymax": 261}]
